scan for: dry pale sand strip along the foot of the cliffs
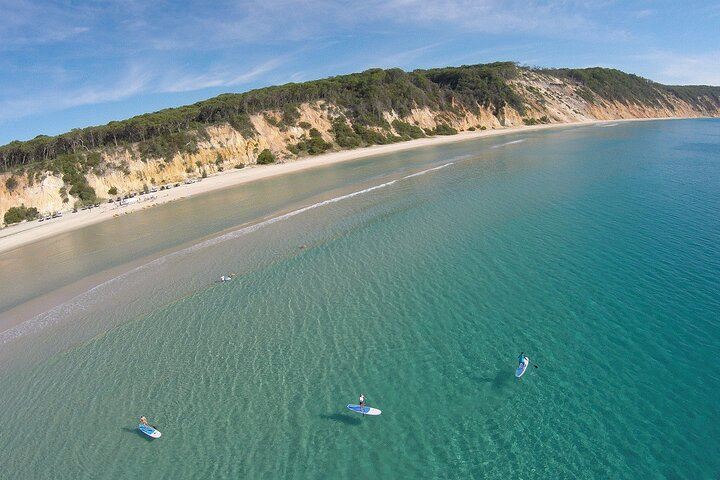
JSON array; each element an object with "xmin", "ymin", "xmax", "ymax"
[{"xmin": 0, "ymin": 117, "xmax": 681, "ymax": 254}]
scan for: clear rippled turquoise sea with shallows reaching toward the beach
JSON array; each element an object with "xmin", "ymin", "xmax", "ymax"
[{"xmin": 0, "ymin": 120, "xmax": 720, "ymax": 479}]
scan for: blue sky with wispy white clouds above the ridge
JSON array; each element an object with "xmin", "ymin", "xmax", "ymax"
[{"xmin": 0, "ymin": 0, "xmax": 720, "ymax": 145}]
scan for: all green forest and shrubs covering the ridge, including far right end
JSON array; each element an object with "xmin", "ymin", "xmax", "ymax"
[{"xmin": 0, "ymin": 62, "xmax": 720, "ymax": 175}]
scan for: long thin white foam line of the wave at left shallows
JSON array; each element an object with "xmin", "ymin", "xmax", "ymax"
[{"xmin": 0, "ymin": 162, "xmax": 454, "ymax": 345}]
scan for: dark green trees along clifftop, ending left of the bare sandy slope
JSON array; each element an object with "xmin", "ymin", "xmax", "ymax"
[{"xmin": 0, "ymin": 62, "xmax": 523, "ymax": 170}]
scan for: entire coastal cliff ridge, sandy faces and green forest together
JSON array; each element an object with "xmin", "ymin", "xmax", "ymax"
[{"xmin": 0, "ymin": 63, "xmax": 720, "ymax": 223}]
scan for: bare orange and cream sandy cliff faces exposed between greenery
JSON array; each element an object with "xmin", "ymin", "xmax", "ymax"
[{"xmin": 0, "ymin": 70, "xmax": 720, "ymax": 223}]
